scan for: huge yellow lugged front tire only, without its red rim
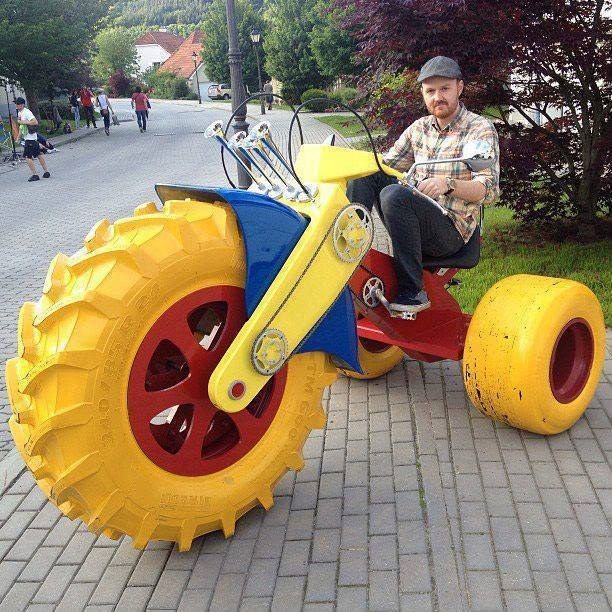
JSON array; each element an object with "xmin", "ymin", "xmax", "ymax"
[{"xmin": 6, "ymin": 200, "xmax": 336, "ymax": 550}]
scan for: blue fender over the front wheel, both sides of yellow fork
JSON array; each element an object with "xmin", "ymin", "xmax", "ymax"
[{"xmin": 155, "ymin": 185, "xmax": 361, "ymax": 372}]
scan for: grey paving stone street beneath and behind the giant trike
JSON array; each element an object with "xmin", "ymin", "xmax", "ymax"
[{"xmin": 0, "ymin": 100, "xmax": 612, "ymax": 611}]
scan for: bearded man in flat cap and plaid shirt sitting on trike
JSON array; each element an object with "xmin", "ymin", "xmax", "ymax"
[{"xmin": 347, "ymin": 56, "xmax": 499, "ymax": 312}]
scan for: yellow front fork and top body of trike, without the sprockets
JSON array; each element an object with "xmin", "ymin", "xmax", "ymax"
[{"xmin": 208, "ymin": 144, "xmax": 401, "ymax": 412}]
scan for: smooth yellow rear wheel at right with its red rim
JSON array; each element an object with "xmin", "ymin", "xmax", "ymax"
[{"xmin": 463, "ymin": 274, "xmax": 605, "ymax": 434}]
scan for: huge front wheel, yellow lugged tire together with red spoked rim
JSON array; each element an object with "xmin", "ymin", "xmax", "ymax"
[{"xmin": 6, "ymin": 200, "xmax": 336, "ymax": 550}]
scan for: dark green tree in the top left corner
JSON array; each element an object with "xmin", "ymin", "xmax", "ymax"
[{"xmin": 0, "ymin": 0, "xmax": 108, "ymax": 115}]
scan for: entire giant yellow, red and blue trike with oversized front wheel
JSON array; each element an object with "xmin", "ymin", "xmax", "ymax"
[{"xmin": 6, "ymin": 104, "xmax": 604, "ymax": 550}]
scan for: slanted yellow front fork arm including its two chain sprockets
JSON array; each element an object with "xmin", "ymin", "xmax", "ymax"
[{"xmin": 208, "ymin": 184, "xmax": 374, "ymax": 412}]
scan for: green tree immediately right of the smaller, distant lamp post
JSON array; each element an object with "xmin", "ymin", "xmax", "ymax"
[{"xmin": 263, "ymin": 0, "xmax": 331, "ymax": 102}]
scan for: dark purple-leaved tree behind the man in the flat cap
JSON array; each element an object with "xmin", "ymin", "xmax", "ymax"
[{"xmin": 336, "ymin": 0, "xmax": 612, "ymax": 232}]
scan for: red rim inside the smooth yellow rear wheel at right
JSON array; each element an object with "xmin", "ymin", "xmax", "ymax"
[{"xmin": 549, "ymin": 319, "xmax": 594, "ymax": 404}]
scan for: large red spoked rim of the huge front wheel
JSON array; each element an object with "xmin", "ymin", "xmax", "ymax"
[{"xmin": 127, "ymin": 286, "xmax": 287, "ymax": 476}]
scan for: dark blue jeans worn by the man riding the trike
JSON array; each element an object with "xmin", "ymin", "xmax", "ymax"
[{"xmin": 347, "ymin": 172, "xmax": 464, "ymax": 294}]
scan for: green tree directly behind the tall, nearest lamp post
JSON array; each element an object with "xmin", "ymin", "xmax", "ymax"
[{"xmin": 201, "ymin": 0, "xmax": 265, "ymax": 91}]
